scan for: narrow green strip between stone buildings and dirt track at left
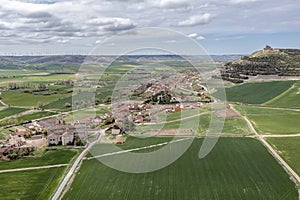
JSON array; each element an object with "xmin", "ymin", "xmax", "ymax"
[{"xmin": 0, "ymin": 149, "xmax": 78, "ymax": 170}]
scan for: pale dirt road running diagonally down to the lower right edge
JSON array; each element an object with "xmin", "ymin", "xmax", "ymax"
[{"xmin": 229, "ymin": 104, "xmax": 300, "ymax": 183}]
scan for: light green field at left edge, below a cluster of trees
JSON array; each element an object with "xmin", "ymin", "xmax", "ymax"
[{"xmin": 1, "ymin": 91, "xmax": 70, "ymax": 107}]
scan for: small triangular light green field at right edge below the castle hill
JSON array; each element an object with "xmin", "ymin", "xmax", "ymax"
[{"xmin": 265, "ymin": 82, "xmax": 300, "ymax": 108}]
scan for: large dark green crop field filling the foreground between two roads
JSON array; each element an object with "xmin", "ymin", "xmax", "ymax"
[{"xmin": 63, "ymin": 138, "xmax": 298, "ymax": 200}]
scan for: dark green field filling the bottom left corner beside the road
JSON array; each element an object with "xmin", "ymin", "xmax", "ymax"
[{"xmin": 0, "ymin": 167, "xmax": 65, "ymax": 200}]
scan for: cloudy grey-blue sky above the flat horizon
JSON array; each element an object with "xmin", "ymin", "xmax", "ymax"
[{"xmin": 0, "ymin": 0, "xmax": 300, "ymax": 55}]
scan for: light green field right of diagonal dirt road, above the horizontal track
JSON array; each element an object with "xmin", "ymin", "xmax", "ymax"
[{"xmin": 236, "ymin": 106, "xmax": 300, "ymax": 134}]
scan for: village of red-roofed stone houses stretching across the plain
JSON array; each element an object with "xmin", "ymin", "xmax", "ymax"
[{"xmin": 0, "ymin": 72, "xmax": 212, "ymax": 160}]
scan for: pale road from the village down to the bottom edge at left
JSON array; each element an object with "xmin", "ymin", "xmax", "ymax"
[{"xmin": 52, "ymin": 129, "xmax": 106, "ymax": 200}]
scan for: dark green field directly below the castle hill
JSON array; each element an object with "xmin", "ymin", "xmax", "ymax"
[{"xmin": 213, "ymin": 81, "xmax": 295, "ymax": 104}]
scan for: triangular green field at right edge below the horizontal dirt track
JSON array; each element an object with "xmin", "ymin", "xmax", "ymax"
[{"xmin": 267, "ymin": 137, "xmax": 300, "ymax": 174}]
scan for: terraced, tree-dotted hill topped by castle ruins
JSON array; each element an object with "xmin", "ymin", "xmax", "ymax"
[{"xmin": 222, "ymin": 45, "xmax": 300, "ymax": 83}]
